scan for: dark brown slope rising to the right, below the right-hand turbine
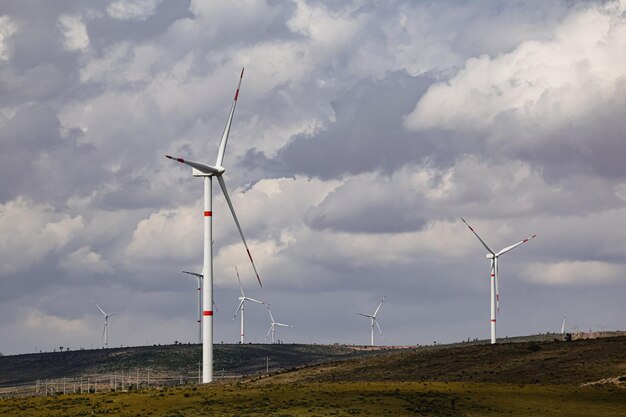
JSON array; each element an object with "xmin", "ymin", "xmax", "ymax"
[{"xmin": 256, "ymin": 336, "xmax": 626, "ymax": 384}]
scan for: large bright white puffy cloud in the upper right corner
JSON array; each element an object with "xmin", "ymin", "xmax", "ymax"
[{"xmin": 405, "ymin": 2, "xmax": 626, "ymax": 130}]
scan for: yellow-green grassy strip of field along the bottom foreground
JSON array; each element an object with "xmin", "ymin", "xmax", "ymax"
[{"xmin": 0, "ymin": 382, "xmax": 626, "ymax": 417}]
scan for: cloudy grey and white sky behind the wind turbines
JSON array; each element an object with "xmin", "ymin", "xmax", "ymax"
[{"xmin": 0, "ymin": 0, "xmax": 626, "ymax": 354}]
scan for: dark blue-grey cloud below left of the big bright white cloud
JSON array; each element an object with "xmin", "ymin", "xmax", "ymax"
[{"xmin": 277, "ymin": 73, "xmax": 433, "ymax": 179}]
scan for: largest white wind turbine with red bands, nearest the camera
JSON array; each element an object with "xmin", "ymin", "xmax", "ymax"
[{"xmin": 166, "ymin": 69, "xmax": 261, "ymax": 384}]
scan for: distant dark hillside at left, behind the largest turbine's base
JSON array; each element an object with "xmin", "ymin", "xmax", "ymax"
[{"xmin": 0, "ymin": 344, "xmax": 380, "ymax": 386}]
